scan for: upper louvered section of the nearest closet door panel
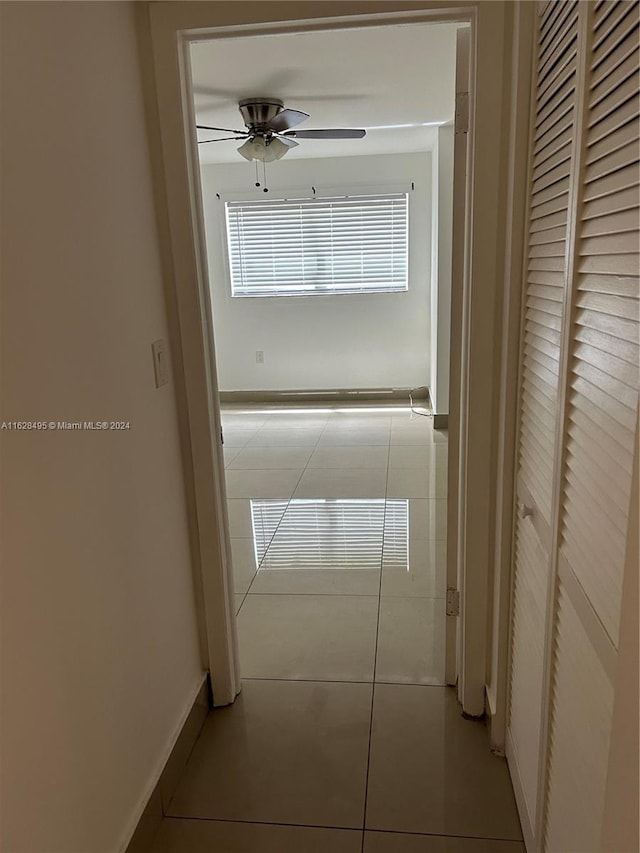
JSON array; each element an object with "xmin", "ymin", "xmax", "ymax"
[{"xmin": 560, "ymin": 0, "xmax": 640, "ymax": 645}]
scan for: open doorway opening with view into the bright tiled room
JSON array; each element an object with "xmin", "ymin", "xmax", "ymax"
[{"xmin": 190, "ymin": 23, "xmax": 459, "ymax": 696}]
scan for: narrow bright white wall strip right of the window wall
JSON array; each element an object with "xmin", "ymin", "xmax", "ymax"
[{"xmin": 429, "ymin": 125, "xmax": 454, "ymax": 415}]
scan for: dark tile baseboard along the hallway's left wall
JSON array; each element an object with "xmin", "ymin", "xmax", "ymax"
[{"xmin": 122, "ymin": 674, "xmax": 212, "ymax": 853}]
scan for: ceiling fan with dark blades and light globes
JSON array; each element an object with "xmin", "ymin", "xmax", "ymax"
[{"xmin": 197, "ymin": 98, "xmax": 366, "ymax": 163}]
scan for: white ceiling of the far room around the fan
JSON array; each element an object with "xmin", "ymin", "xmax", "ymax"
[{"xmin": 191, "ymin": 24, "xmax": 459, "ymax": 163}]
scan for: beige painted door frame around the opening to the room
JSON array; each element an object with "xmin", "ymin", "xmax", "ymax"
[{"xmin": 141, "ymin": 0, "xmax": 508, "ymax": 716}]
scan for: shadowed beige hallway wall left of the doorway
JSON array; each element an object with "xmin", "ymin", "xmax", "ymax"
[{"xmin": 0, "ymin": 2, "xmax": 202, "ymax": 853}]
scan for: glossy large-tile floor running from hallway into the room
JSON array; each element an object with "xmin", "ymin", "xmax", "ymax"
[{"xmin": 154, "ymin": 406, "xmax": 524, "ymax": 853}]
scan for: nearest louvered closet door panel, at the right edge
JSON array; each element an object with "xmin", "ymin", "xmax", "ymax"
[{"xmin": 545, "ymin": 0, "xmax": 640, "ymax": 853}]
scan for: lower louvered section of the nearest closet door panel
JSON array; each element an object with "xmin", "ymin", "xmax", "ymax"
[{"xmin": 544, "ymin": 582, "xmax": 613, "ymax": 853}]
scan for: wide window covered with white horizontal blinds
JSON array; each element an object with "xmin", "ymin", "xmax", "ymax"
[{"xmin": 226, "ymin": 193, "xmax": 408, "ymax": 296}]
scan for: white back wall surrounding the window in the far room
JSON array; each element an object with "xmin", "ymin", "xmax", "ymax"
[{"xmin": 202, "ymin": 152, "xmax": 431, "ymax": 391}]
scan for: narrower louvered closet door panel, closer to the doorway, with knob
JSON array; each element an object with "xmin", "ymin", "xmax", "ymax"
[{"xmin": 507, "ymin": 2, "xmax": 579, "ymax": 834}]
